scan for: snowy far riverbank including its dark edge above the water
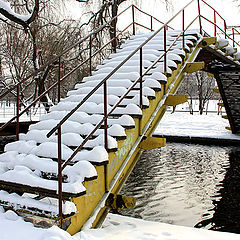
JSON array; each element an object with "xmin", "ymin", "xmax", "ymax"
[{"xmin": 153, "ymin": 112, "xmax": 240, "ymax": 146}]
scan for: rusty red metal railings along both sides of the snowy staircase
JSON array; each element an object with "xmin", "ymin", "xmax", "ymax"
[{"xmin": 0, "ymin": 0, "xmax": 239, "ymax": 225}]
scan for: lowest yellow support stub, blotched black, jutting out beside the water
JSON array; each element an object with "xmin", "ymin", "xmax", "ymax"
[{"xmin": 105, "ymin": 193, "xmax": 136, "ymax": 209}]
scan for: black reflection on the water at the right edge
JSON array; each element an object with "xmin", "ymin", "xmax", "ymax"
[{"xmin": 196, "ymin": 149, "xmax": 240, "ymax": 233}]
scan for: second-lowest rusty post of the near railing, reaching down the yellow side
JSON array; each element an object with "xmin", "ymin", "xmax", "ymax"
[{"xmin": 103, "ymin": 81, "xmax": 108, "ymax": 192}]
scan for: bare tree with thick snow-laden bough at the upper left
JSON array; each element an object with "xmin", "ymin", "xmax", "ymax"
[{"xmin": 0, "ymin": 0, "xmax": 87, "ymax": 110}]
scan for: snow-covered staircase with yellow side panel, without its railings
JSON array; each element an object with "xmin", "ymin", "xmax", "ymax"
[{"xmin": 0, "ymin": 30, "xmax": 202, "ymax": 231}]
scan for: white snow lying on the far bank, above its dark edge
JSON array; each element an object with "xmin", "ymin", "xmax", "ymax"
[{"xmin": 155, "ymin": 112, "xmax": 240, "ymax": 140}]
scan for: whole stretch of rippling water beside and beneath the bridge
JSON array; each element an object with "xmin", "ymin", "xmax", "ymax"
[{"xmin": 121, "ymin": 143, "xmax": 240, "ymax": 233}]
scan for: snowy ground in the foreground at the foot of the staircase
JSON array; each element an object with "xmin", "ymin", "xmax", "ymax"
[{"xmin": 0, "ymin": 208, "xmax": 240, "ymax": 240}]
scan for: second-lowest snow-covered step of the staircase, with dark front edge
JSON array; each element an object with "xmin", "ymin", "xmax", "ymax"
[{"xmin": 0, "ymin": 155, "xmax": 96, "ymax": 199}]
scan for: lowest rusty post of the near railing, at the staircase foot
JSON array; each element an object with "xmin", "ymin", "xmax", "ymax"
[{"xmin": 58, "ymin": 126, "xmax": 63, "ymax": 228}]
